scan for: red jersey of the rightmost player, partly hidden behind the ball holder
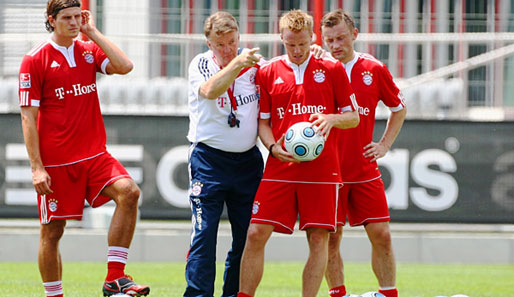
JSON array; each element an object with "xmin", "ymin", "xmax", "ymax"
[{"xmin": 338, "ymin": 52, "xmax": 405, "ymax": 182}]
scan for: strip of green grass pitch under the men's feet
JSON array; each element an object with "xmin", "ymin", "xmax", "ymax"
[{"xmin": 0, "ymin": 262, "xmax": 514, "ymax": 297}]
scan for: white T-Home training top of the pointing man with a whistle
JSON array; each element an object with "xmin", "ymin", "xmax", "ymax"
[{"xmin": 187, "ymin": 50, "xmax": 259, "ymax": 153}]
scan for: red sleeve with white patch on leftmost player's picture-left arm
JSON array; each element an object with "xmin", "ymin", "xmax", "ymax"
[{"xmin": 18, "ymin": 55, "xmax": 42, "ymax": 106}]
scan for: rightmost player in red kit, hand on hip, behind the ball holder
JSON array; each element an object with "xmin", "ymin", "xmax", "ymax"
[{"xmin": 321, "ymin": 10, "xmax": 406, "ymax": 297}]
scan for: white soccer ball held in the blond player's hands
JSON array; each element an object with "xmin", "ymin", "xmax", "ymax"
[{"xmin": 284, "ymin": 122, "xmax": 325, "ymax": 161}]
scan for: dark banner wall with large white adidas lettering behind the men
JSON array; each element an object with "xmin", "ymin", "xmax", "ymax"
[{"xmin": 0, "ymin": 114, "xmax": 514, "ymax": 223}]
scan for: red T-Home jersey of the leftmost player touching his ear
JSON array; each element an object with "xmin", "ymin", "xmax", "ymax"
[{"xmin": 19, "ymin": 40, "xmax": 109, "ymax": 166}]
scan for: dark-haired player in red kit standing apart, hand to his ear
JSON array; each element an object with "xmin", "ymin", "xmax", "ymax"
[{"xmin": 19, "ymin": 0, "xmax": 150, "ymax": 296}]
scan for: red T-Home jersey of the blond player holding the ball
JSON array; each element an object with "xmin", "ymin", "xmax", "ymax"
[{"xmin": 256, "ymin": 55, "xmax": 356, "ymax": 183}]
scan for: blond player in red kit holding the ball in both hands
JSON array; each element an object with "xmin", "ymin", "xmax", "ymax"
[{"xmin": 238, "ymin": 10, "xmax": 358, "ymax": 297}]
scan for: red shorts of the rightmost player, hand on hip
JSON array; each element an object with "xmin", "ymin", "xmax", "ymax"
[{"xmin": 337, "ymin": 178, "xmax": 390, "ymax": 226}]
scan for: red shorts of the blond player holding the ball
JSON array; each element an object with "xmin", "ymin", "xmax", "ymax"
[{"xmin": 251, "ymin": 180, "xmax": 339, "ymax": 234}]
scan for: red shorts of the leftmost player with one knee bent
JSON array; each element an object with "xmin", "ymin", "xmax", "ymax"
[{"xmin": 37, "ymin": 152, "xmax": 131, "ymax": 224}]
